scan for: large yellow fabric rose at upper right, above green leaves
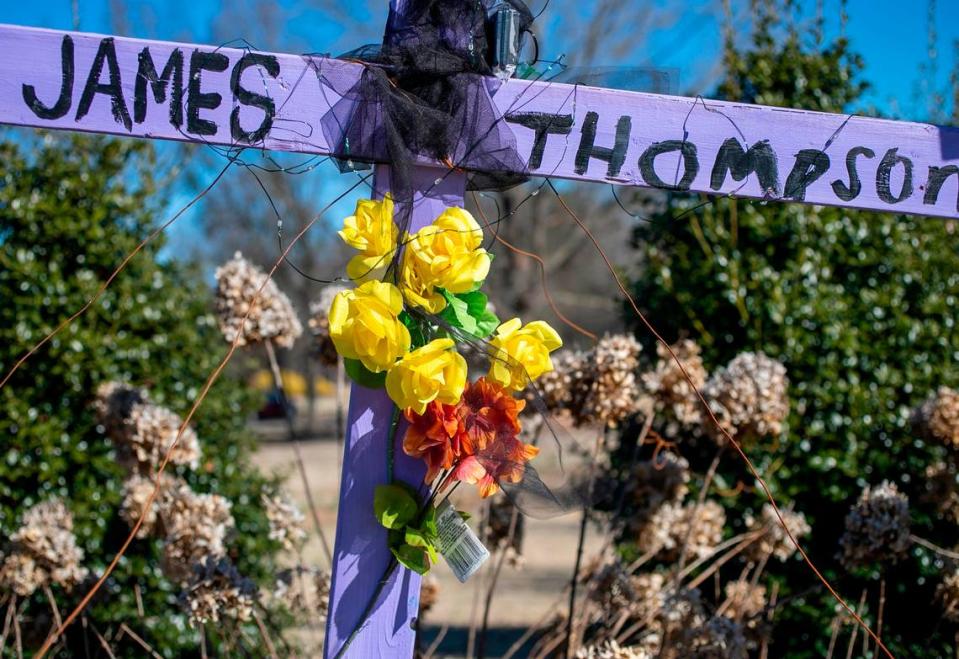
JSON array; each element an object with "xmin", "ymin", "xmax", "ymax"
[{"xmin": 401, "ymin": 207, "xmax": 490, "ymax": 313}]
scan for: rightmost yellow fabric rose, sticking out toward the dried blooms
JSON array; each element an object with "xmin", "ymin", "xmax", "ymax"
[{"xmin": 487, "ymin": 318, "xmax": 563, "ymax": 391}]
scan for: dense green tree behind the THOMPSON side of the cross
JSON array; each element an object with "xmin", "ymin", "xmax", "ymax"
[{"xmin": 627, "ymin": 2, "xmax": 959, "ymax": 657}]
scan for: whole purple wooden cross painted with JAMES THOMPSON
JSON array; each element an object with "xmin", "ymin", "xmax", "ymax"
[{"xmin": 0, "ymin": 0, "xmax": 959, "ymax": 658}]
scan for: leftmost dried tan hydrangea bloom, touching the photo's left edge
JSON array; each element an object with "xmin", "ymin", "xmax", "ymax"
[{"xmin": 0, "ymin": 499, "xmax": 89, "ymax": 596}]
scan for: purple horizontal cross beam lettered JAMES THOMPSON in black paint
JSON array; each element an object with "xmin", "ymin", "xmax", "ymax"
[{"xmin": 0, "ymin": 25, "xmax": 959, "ymax": 218}]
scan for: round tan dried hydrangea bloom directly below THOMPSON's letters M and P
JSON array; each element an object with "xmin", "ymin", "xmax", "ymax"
[{"xmin": 703, "ymin": 352, "xmax": 789, "ymax": 444}]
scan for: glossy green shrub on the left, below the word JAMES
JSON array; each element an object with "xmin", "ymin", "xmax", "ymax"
[{"xmin": 0, "ymin": 135, "xmax": 278, "ymax": 656}]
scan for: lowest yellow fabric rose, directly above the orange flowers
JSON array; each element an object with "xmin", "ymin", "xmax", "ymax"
[{"xmin": 386, "ymin": 339, "xmax": 466, "ymax": 414}]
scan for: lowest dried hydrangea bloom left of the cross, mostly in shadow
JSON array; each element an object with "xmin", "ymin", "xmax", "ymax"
[{"xmin": 179, "ymin": 557, "xmax": 257, "ymax": 625}]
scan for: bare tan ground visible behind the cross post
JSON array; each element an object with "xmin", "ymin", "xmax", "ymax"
[{"xmin": 254, "ymin": 406, "xmax": 603, "ymax": 656}]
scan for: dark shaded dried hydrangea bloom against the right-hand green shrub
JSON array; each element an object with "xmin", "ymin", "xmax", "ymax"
[{"xmin": 839, "ymin": 481, "xmax": 910, "ymax": 569}]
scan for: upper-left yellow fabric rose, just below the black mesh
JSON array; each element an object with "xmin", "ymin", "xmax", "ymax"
[{"xmin": 339, "ymin": 195, "xmax": 399, "ymax": 282}]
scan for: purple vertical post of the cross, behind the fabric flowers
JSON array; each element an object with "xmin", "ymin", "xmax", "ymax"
[{"xmin": 324, "ymin": 6, "xmax": 466, "ymax": 658}]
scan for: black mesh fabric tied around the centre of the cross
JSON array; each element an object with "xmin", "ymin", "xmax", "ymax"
[{"xmin": 321, "ymin": 0, "xmax": 533, "ymax": 233}]
